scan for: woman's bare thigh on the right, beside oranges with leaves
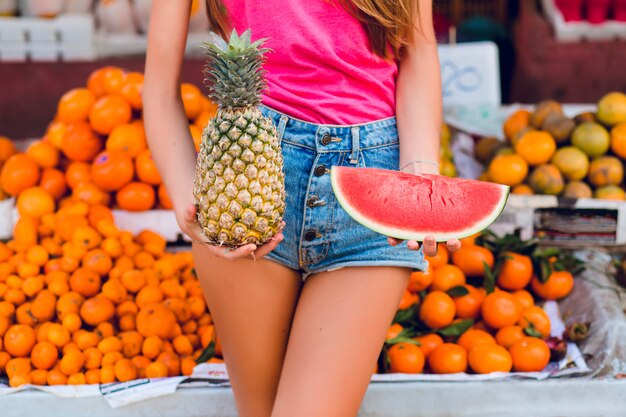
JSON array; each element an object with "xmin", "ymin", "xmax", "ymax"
[{"xmin": 272, "ymin": 267, "xmax": 410, "ymax": 417}]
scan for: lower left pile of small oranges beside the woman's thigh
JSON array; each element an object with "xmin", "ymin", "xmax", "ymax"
[{"xmin": 0, "ymin": 199, "xmax": 221, "ymax": 387}]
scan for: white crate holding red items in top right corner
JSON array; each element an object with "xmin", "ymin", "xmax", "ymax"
[{"xmin": 541, "ymin": 0, "xmax": 626, "ymax": 42}]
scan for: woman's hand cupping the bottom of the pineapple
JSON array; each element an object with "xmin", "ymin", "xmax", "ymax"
[{"xmin": 178, "ymin": 204, "xmax": 285, "ymax": 260}]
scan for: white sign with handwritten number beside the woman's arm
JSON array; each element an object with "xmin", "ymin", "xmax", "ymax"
[{"xmin": 438, "ymin": 42, "xmax": 502, "ymax": 106}]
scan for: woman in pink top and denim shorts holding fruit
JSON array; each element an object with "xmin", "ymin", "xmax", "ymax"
[{"xmin": 144, "ymin": 0, "xmax": 460, "ymax": 417}]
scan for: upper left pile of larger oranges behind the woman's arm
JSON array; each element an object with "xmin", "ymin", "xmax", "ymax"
[{"xmin": 0, "ymin": 67, "xmax": 216, "ymax": 211}]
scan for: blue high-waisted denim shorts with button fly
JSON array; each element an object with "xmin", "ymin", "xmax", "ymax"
[{"xmin": 261, "ymin": 106, "xmax": 426, "ymax": 280}]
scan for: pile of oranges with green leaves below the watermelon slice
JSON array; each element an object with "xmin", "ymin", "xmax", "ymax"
[{"xmin": 377, "ymin": 234, "xmax": 574, "ymax": 374}]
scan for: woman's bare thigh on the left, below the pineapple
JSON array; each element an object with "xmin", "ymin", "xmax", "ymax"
[{"xmin": 193, "ymin": 244, "xmax": 302, "ymax": 417}]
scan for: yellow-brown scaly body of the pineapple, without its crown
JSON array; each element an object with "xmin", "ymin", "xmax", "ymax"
[{"xmin": 194, "ymin": 106, "xmax": 285, "ymax": 248}]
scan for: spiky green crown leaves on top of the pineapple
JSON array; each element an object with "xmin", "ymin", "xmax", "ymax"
[{"xmin": 203, "ymin": 29, "xmax": 270, "ymax": 109}]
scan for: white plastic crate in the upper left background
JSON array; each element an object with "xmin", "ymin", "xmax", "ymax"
[{"xmin": 0, "ymin": 15, "xmax": 96, "ymax": 62}]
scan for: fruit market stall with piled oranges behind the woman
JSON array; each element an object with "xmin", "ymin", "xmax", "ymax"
[{"xmin": 0, "ymin": 1, "xmax": 626, "ymax": 417}]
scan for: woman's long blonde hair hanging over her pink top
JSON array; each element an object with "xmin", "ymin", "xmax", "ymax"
[{"xmin": 206, "ymin": 0, "xmax": 419, "ymax": 58}]
